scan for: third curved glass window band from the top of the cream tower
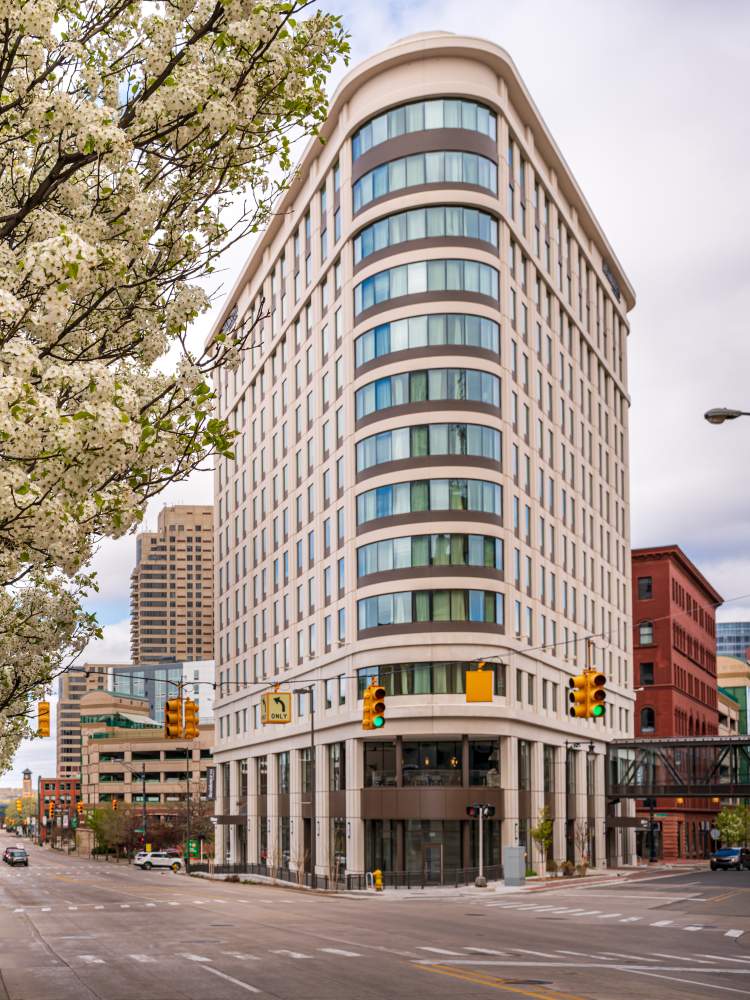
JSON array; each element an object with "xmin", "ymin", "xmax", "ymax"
[{"xmin": 354, "ymin": 205, "xmax": 497, "ymax": 264}]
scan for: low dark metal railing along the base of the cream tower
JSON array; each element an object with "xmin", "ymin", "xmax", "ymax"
[{"xmin": 190, "ymin": 862, "xmax": 503, "ymax": 892}]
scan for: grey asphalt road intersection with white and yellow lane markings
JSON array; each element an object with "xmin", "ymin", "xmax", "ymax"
[{"xmin": 0, "ymin": 839, "xmax": 750, "ymax": 1000}]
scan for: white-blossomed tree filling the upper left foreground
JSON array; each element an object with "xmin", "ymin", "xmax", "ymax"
[{"xmin": 0, "ymin": 0, "xmax": 348, "ymax": 773}]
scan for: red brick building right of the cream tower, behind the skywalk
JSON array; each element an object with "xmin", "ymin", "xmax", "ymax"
[{"xmin": 632, "ymin": 545, "xmax": 723, "ymax": 858}]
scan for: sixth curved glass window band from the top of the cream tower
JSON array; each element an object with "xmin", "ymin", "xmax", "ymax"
[{"xmin": 354, "ymin": 368, "xmax": 500, "ymax": 420}]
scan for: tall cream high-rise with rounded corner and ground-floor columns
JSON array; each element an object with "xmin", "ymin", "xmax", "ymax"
[{"xmin": 215, "ymin": 32, "xmax": 634, "ymax": 879}]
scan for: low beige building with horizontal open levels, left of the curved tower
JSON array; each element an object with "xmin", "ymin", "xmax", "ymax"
[{"xmin": 81, "ymin": 692, "xmax": 213, "ymax": 821}]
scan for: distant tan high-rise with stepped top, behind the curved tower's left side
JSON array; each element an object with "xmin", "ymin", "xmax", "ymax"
[{"xmin": 130, "ymin": 506, "xmax": 214, "ymax": 663}]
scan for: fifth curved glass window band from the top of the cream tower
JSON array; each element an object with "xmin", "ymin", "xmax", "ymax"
[{"xmin": 354, "ymin": 313, "xmax": 500, "ymax": 368}]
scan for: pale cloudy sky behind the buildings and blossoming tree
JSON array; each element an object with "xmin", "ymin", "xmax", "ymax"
[{"xmin": 7, "ymin": 0, "xmax": 750, "ymax": 784}]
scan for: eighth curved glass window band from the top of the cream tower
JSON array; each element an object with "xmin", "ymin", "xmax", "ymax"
[{"xmin": 357, "ymin": 479, "xmax": 503, "ymax": 524}]
